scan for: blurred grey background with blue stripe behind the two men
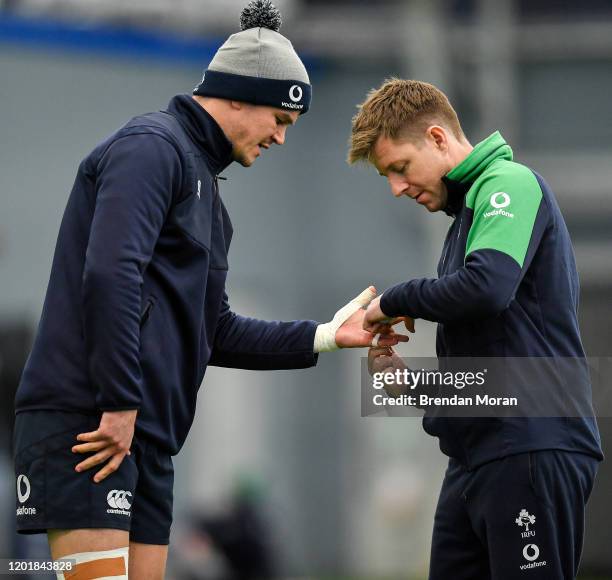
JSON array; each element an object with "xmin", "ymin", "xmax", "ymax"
[{"xmin": 0, "ymin": 0, "xmax": 612, "ymax": 579}]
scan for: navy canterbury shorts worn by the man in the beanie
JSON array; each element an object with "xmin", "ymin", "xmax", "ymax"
[{"xmin": 13, "ymin": 411, "xmax": 174, "ymax": 545}]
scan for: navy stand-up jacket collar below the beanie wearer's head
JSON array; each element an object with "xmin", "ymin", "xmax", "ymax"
[{"xmin": 168, "ymin": 95, "xmax": 233, "ymax": 174}]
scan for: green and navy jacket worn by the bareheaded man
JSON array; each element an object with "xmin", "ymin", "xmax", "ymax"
[{"xmin": 381, "ymin": 132, "xmax": 602, "ymax": 467}]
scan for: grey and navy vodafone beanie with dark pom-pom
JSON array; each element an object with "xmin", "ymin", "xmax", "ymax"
[{"xmin": 193, "ymin": 0, "xmax": 312, "ymax": 114}]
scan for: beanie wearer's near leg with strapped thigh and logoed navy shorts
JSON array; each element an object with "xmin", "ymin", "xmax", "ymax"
[{"xmin": 15, "ymin": 411, "xmax": 138, "ymax": 578}]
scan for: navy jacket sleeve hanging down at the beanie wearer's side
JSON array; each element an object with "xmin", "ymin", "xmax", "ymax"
[{"xmin": 82, "ymin": 134, "xmax": 181, "ymax": 411}]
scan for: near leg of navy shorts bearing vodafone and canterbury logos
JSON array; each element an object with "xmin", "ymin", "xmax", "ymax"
[{"xmin": 15, "ymin": 411, "xmax": 138, "ymax": 533}]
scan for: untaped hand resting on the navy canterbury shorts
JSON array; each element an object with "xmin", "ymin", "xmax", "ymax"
[{"xmin": 72, "ymin": 410, "xmax": 138, "ymax": 483}]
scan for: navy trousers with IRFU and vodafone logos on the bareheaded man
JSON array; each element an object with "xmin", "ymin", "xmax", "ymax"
[{"xmin": 429, "ymin": 450, "xmax": 599, "ymax": 580}]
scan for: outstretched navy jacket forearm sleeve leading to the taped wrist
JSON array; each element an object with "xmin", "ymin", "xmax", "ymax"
[{"xmin": 208, "ymin": 294, "xmax": 318, "ymax": 370}]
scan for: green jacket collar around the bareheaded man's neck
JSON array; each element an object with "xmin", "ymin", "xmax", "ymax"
[{"xmin": 442, "ymin": 131, "xmax": 512, "ymax": 216}]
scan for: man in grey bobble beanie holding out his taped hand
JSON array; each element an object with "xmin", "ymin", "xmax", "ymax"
[{"xmin": 14, "ymin": 0, "xmax": 405, "ymax": 579}]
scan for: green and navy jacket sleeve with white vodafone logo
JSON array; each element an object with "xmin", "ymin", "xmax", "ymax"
[{"xmin": 380, "ymin": 164, "xmax": 549, "ymax": 323}]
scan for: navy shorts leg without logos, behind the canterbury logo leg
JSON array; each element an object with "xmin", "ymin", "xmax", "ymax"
[{"xmin": 130, "ymin": 438, "xmax": 174, "ymax": 546}]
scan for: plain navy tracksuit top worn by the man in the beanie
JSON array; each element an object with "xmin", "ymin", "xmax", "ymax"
[{"xmin": 15, "ymin": 95, "xmax": 317, "ymax": 454}]
